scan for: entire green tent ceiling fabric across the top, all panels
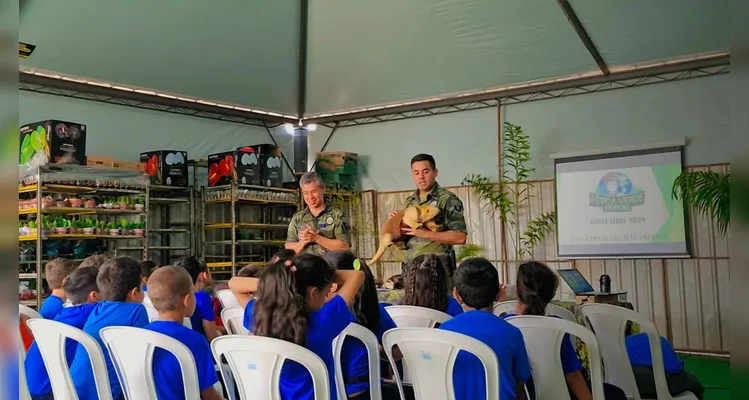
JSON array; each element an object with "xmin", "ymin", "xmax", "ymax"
[{"xmin": 20, "ymin": 0, "xmax": 730, "ymax": 117}]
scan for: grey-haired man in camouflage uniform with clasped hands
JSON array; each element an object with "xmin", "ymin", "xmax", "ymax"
[{"xmin": 284, "ymin": 172, "xmax": 351, "ymax": 256}]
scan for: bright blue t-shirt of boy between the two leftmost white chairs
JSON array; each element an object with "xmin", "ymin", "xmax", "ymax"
[{"xmin": 70, "ymin": 301, "xmax": 148, "ymax": 400}]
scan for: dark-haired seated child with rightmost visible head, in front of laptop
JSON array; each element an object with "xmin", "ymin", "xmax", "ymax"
[{"xmin": 503, "ymin": 261, "xmax": 626, "ymax": 400}]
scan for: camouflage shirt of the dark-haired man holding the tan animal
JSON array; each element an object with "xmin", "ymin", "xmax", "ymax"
[{"xmin": 404, "ymin": 183, "xmax": 466, "ymax": 262}]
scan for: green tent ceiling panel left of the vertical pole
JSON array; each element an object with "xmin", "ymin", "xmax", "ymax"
[{"xmin": 20, "ymin": 0, "xmax": 299, "ymax": 115}]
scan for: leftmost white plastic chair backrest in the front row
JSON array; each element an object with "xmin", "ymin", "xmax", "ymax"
[{"xmin": 26, "ymin": 318, "xmax": 112, "ymax": 400}]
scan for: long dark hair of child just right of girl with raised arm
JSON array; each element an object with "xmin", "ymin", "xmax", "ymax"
[{"xmin": 323, "ymin": 250, "xmax": 380, "ymax": 333}]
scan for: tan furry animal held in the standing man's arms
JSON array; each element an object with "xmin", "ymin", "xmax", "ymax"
[{"xmin": 369, "ymin": 205, "xmax": 440, "ymax": 265}]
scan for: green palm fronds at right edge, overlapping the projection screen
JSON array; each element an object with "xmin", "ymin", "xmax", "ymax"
[{"xmin": 671, "ymin": 171, "xmax": 731, "ymax": 235}]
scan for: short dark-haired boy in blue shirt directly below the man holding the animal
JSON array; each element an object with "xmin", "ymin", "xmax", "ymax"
[{"xmin": 439, "ymin": 258, "xmax": 531, "ymax": 400}]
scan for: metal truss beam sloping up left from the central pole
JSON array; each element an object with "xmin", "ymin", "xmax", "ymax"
[{"xmin": 19, "ymin": 70, "xmax": 298, "ymax": 124}]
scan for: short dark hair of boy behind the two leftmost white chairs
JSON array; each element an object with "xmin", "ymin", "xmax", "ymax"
[{"xmin": 96, "ymin": 257, "xmax": 142, "ymax": 301}]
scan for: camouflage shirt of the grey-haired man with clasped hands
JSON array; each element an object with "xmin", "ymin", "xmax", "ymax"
[{"xmin": 286, "ymin": 207, "xmax": 351, "ymax": 256}]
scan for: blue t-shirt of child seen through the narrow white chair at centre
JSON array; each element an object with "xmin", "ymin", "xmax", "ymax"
[{"xmin": 341, "ymin": 304, "xmax": 396, "ymax": 396}]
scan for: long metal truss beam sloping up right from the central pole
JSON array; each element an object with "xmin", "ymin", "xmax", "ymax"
[{"xmin": 304, "ymin": 53, "xmax": 731, "ymax": 125}]
